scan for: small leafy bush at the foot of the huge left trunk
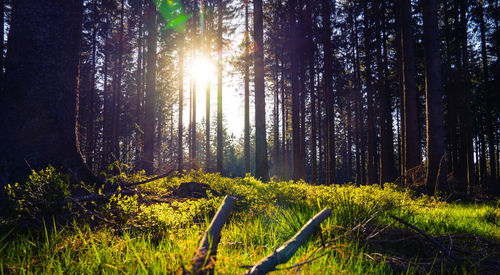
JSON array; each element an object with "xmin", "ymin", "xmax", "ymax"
[{"xmin": 6, "ymin": 165, "xmax": 71, "ymax": 220}]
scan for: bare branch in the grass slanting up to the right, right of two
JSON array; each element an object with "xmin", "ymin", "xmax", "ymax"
[{"xmin": 246, "ymin": 208, "xmax": 332, "ymax": 274}]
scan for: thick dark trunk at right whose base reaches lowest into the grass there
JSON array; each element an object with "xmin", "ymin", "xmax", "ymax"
[{"xmin": 423, "ymin": 0, "xmax": 448, "ymax": 194}]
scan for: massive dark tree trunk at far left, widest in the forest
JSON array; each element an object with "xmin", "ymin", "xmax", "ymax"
[{"xmin": 0, "ymin": 0, "xmax": 96, "ymax": 190}]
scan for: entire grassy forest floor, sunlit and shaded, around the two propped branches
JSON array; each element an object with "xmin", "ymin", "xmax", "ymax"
[{"xmin": 0, "ymin": 172, "xmax": 500, "ymax": 274}]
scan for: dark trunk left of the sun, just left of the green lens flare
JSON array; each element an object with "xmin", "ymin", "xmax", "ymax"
[{"xmin": 143, "ymin": 1, "xmax": 158, "ymax": 174}]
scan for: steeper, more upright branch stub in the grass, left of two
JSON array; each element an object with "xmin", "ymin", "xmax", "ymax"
[{"xmin": 191, "ymin": 196, "xmax": 235, "ymax": 274}]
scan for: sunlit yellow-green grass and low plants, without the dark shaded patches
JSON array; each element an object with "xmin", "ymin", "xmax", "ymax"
[{"xmin": 0, "ymin": 171, "xmax": 500, "ymax": 274}]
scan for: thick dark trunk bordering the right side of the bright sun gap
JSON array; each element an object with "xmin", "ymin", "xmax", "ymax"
[{"xmin": 253, "ymin": 0, "xmax": 269, "ymax": 181}]
